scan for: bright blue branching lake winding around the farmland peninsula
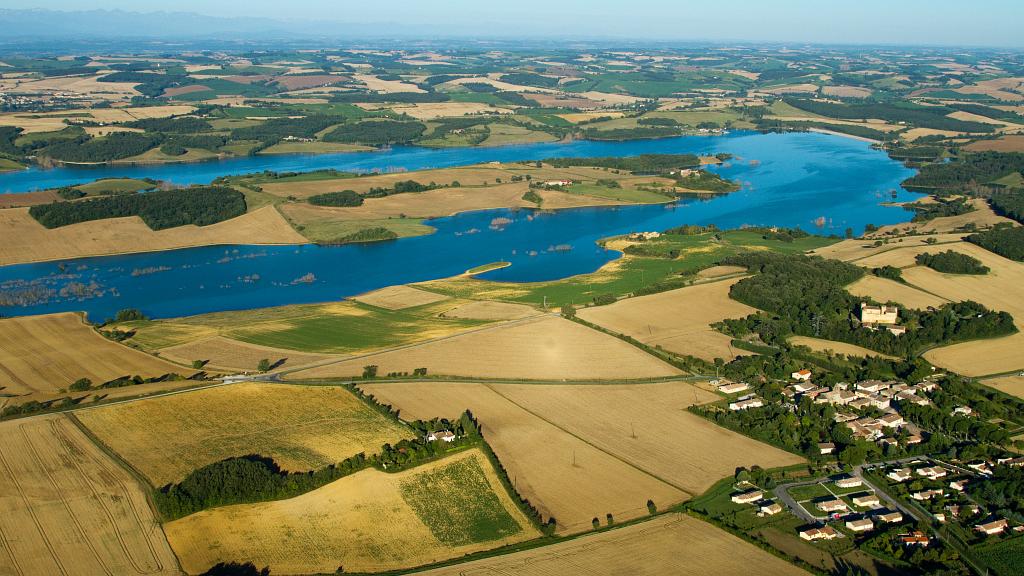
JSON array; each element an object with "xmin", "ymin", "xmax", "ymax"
[{"xmin": 0, "ymin": 132, "xmax": 920, "ymax": 320}]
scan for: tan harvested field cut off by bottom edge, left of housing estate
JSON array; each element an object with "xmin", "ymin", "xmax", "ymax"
[{"xmin": 422, "ymin": 513, "xmax": 807, "ymax": 576}]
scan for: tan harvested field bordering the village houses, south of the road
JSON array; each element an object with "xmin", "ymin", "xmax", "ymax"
[{"xmin": 490, "ymin": 382, "xmax": 803, "ymax": 494}]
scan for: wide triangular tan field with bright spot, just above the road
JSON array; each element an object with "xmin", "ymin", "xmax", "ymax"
[{"xmin": 290, "ymin": 317, "xmax": 679, "ymax": 380}]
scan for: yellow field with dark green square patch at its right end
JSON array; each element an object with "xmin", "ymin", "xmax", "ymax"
[{"xmin": 166, "ymin": 449, "xmax": 540, "ymax": 574}]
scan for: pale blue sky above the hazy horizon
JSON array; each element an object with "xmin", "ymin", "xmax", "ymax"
[{"xmin": 2, "ymin": 0, "xmax": 1024, "ymax": 47}]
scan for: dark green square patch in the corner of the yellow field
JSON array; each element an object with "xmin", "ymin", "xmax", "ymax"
[{"xmin": 400, "ymin": 458, "xmax": 522, "ymax": 546}]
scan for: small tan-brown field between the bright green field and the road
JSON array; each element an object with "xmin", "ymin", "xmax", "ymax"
[{"xmin": 160, "ymin": 336, "xmax": 332, "ymax": 372}]
